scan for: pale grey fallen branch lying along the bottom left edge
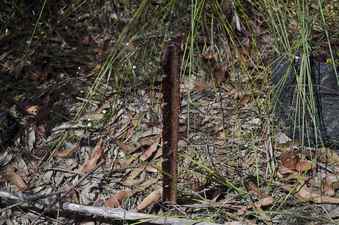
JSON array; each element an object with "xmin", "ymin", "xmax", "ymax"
[{"xmin": 0, "ymin": 191, "xmax": 244, "ymax": 225}]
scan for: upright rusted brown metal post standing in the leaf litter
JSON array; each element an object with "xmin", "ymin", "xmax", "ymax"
[{"xmin": 162, "ymin": 40, "xmax": 180, "ymax": 204}]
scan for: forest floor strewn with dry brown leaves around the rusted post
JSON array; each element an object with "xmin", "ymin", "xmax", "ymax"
[{"xmin": 0, "ymin": 1, "xmax": 339, "ymax": 225}]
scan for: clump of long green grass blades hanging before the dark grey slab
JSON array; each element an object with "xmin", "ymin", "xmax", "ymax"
[{"xmin": 262, "ymin": 0, "xmax": 337, "ymax": 149}]
